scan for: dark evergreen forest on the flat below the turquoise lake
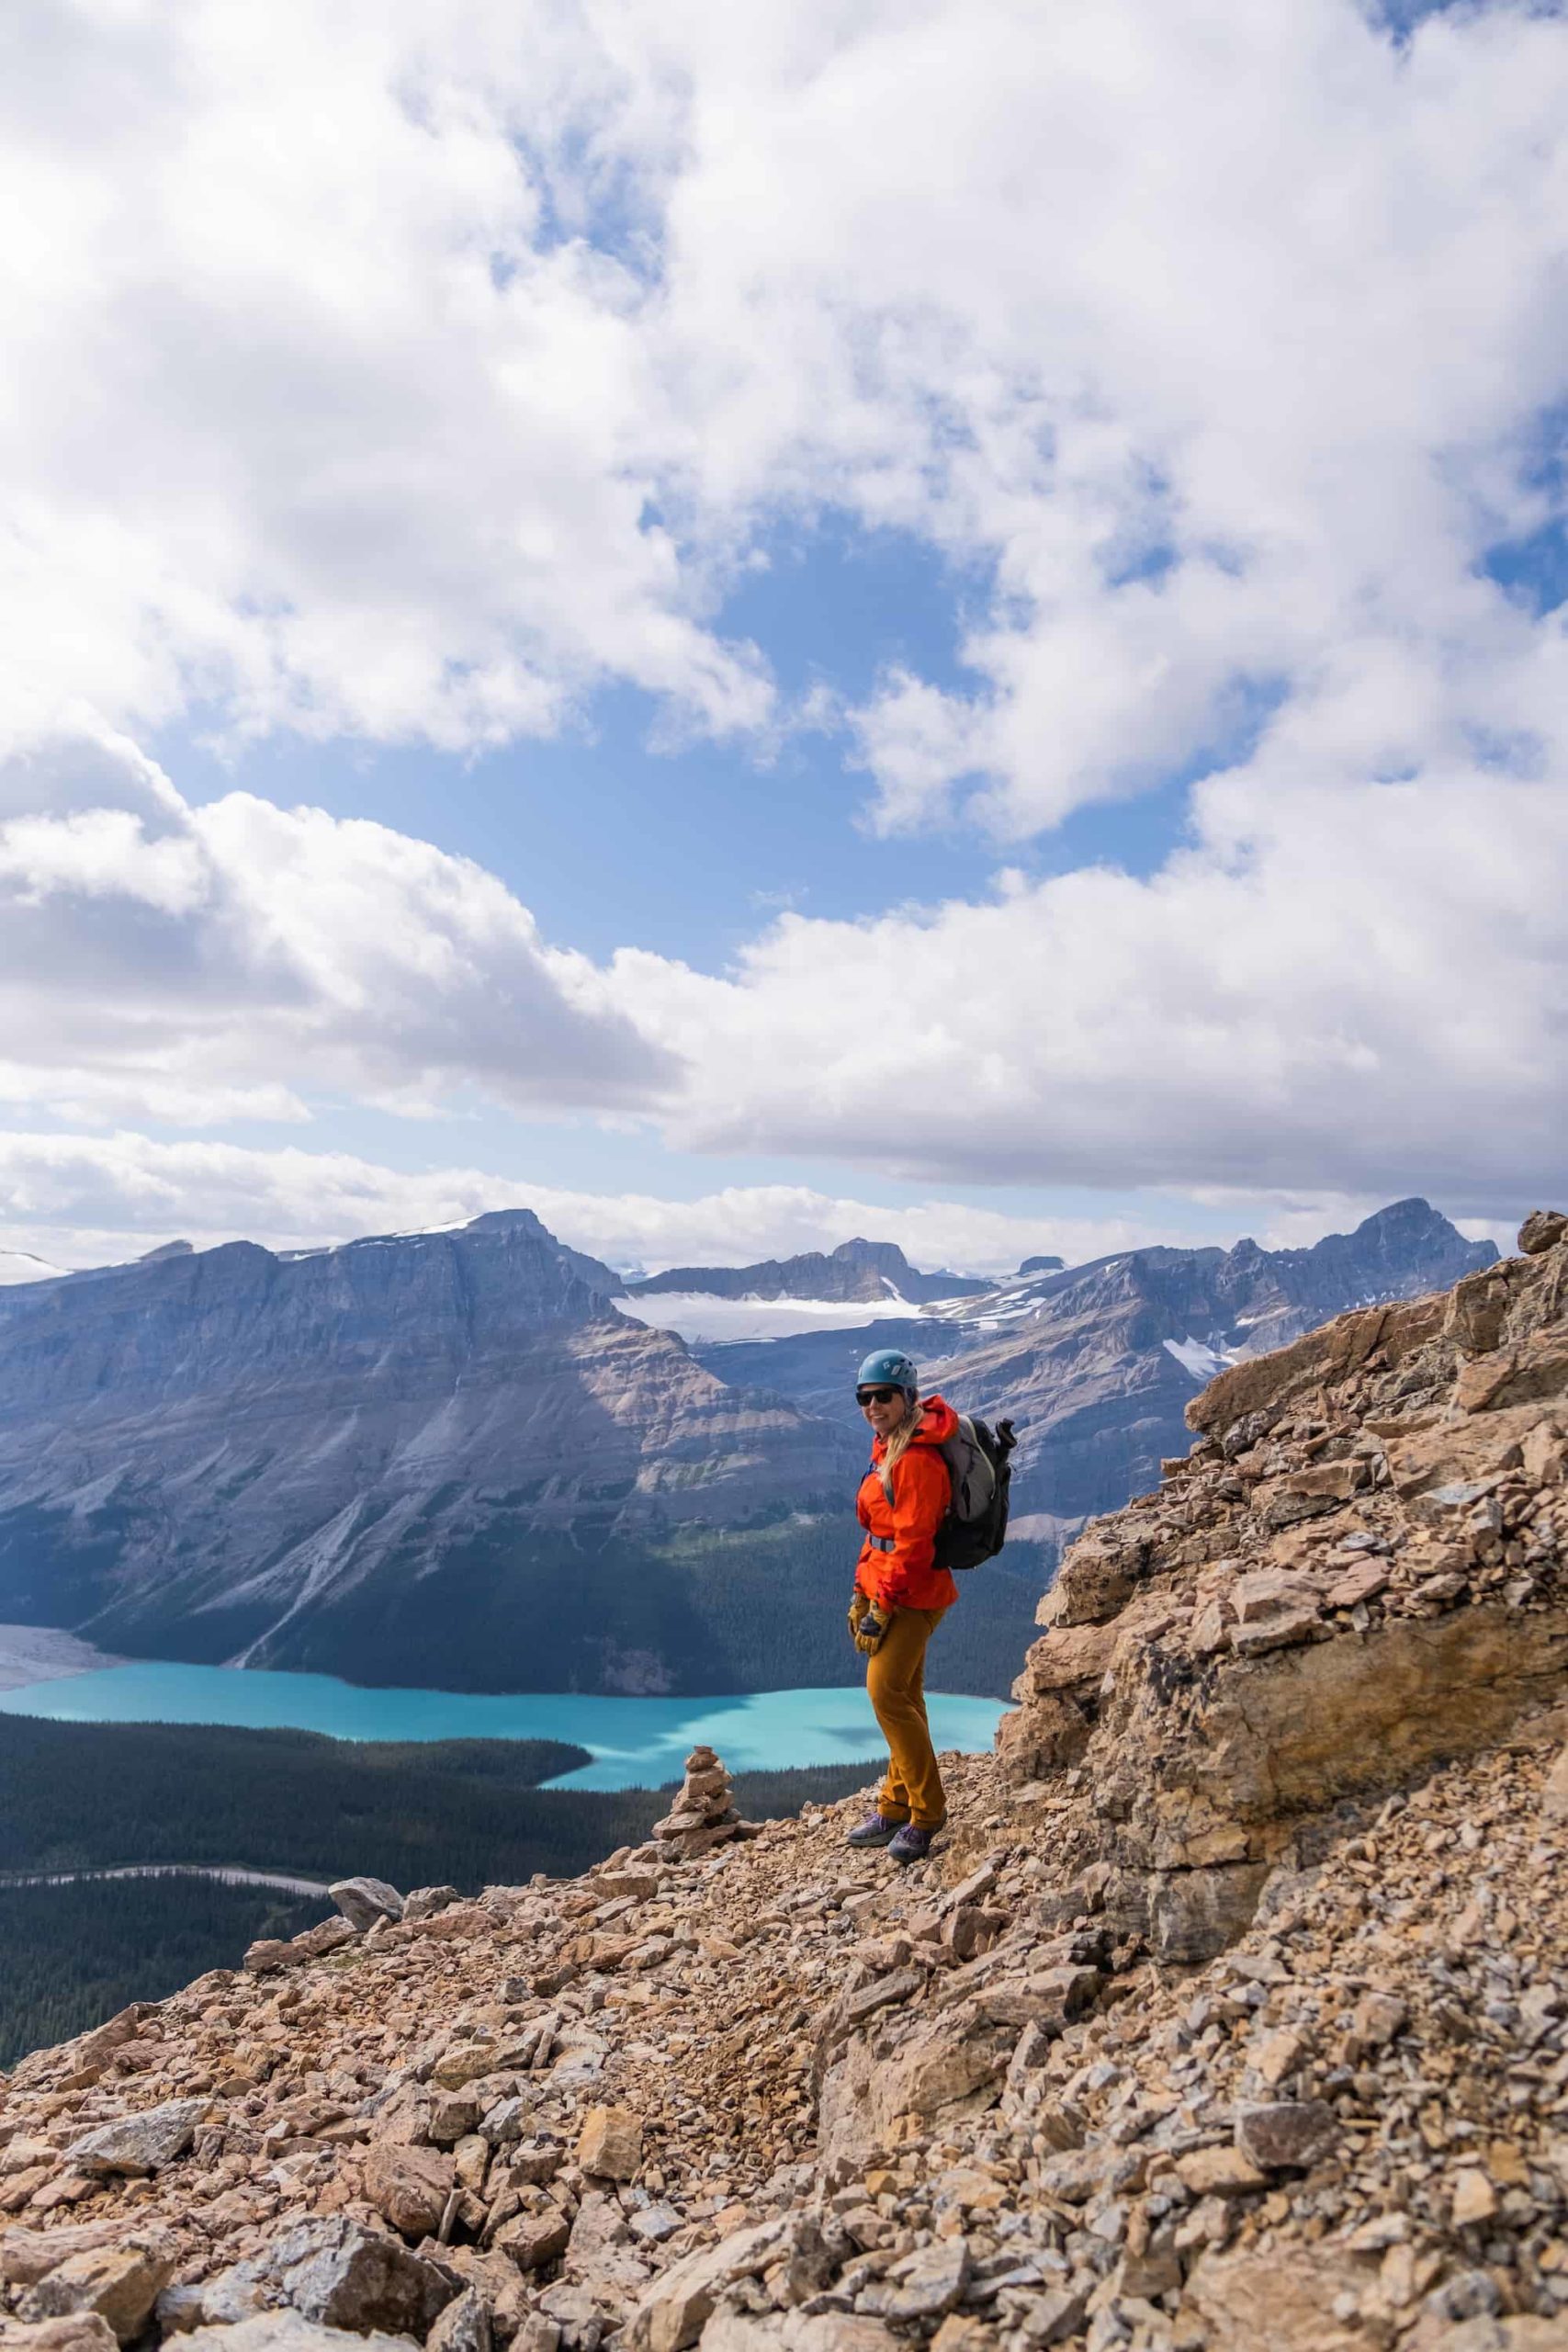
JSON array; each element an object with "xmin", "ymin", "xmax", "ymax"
[{"xmin": 0, "ymin": 1714, "xmax": 872, "ymax": 2067}]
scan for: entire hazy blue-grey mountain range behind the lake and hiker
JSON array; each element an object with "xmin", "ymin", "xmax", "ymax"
[{"xmin": 0, "ymin": 1200, "xmax": 1495, "ymax": 1691}]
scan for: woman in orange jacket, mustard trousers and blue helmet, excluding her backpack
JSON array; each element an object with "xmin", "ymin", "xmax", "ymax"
[{"xmin": 849, "ymin": 1348, "xmax": 959, "ymax": 1863}]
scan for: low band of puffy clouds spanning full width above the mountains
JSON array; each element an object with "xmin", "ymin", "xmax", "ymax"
[{"xmin": 0, "ymin": 729, "xmax": 1568, "ymax": 1213}]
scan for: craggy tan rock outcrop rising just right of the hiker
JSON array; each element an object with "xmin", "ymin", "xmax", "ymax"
[{"xmin": 1004, "ymin": 1204, "xmax": 1568, "ymax": 1959}]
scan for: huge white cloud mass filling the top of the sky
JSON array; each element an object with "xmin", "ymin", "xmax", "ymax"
[{"xmin": 0, "ymin": 0, "xmax": 1568, "ymax": 835}]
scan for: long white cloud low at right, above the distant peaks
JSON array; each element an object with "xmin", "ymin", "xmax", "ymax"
[{"xmin": 616, "ymin": 752, "xmax": 1568, "ymax": 1216}]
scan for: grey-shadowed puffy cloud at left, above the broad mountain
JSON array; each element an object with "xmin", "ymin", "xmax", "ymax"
[{"xmin": 0, "ymin": 739, "xmax": 674, "ymax": 1126}]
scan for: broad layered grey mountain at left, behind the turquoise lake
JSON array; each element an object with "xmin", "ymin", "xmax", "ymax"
[{"xmin": 0, "ymin": 1211, "xmax": 856, "ymax": 1687}]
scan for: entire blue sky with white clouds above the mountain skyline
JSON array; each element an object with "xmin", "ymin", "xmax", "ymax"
[{"xmin": 0, "ymin": 0, "xmax": 1568, "ymax": 1265}]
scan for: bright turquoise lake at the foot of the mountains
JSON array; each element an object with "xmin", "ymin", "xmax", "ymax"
[{"xmin": 0, "ymin": 1660, "xmax": 1006, "ymax": 1788}]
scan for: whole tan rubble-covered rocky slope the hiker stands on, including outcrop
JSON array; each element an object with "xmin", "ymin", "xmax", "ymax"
[{"xmin": 0, "ymin": 1216, "xmax": 1568, "ymax": 2352}]
